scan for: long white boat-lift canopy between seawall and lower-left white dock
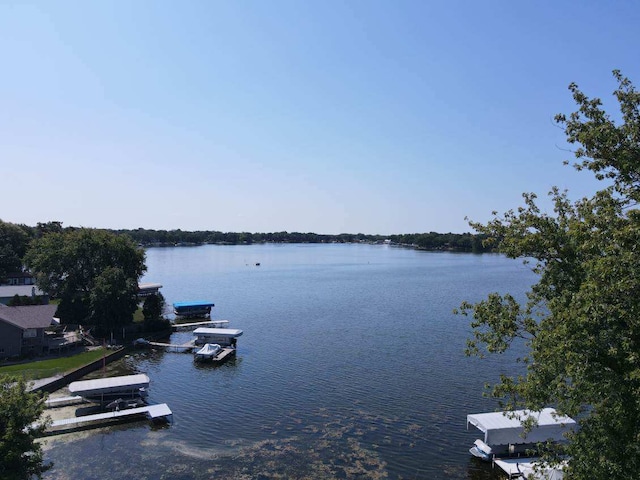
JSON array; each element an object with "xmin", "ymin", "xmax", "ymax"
[{"xmin": 69, "ymin": 374, "xmax": 149, "ymax": 404}]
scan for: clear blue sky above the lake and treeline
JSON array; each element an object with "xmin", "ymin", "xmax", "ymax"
[{"xmin": 0, "ymin": 0, "xmax": 640, "ymax": 234}]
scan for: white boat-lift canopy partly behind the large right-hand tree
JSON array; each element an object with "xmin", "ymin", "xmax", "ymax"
[{"xmin": 467, "ymin": 408, "xmax": 576, "ymax": 445}]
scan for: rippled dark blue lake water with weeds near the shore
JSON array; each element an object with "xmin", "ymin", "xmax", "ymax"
[{"xmin": 44, "ymin": 244, "xmax": 535, "ymax": 480}]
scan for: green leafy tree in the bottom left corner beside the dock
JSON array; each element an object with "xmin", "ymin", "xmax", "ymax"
[{"xmin": 0, "ymin": 376, "xmax": 51, "ymax": 480}]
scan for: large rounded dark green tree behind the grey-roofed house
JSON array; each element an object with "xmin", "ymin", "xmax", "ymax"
[{"xmin": 25, "ymin": 228, "xmax": 146, "ymax": 328}]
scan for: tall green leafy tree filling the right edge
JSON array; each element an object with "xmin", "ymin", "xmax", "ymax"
[{"xmin": 461, "ymin": 71, "xmax": 640, "ymax": 480}]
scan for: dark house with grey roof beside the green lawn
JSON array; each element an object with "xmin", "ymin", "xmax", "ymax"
[{"xmin": 0, "ymin": 304, "xmax": 58, "ymax": 358}]
